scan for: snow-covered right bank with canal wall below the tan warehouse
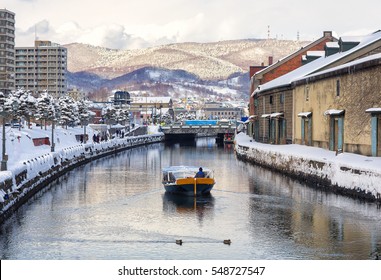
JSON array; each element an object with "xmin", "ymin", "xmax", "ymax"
[{"xmin": 235, "ymin": 133, "xmax": 381, "ymax": 201}]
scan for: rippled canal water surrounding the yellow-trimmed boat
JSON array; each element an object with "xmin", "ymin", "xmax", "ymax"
[{"xmin": 0, "ymin": 138, "xmax": 381, "ymax": 260}]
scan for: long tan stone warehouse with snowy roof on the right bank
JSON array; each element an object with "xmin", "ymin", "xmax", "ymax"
[{"xmin": 253, "ymin": 31, "xmax": 381, "ymax": 156}]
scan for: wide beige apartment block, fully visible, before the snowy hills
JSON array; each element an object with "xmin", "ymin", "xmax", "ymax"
[{"xmin": 16, "ymin": 40, "xmax": 67, "ymax": 98}]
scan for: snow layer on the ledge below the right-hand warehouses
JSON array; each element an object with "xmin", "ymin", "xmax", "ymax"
[{"xmin": 235, "ymin": 133, "xmax": 381, "ymax": 197}]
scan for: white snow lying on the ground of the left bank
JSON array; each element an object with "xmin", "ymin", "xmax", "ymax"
[{"xmin": 0, "ymin": 124, "xmax": 162, "ymax": 205}]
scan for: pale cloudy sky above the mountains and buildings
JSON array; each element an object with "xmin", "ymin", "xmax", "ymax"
[{"xmin": 0, "ymin": 0, "xmax": 381, "ymax": 49}]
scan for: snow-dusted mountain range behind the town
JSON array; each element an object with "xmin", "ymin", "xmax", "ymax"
[{"xmin": 65, "ymin": 39, "xmax": 308, "ymax": 100}]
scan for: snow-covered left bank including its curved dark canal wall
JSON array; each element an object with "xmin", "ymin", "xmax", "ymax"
[{"xmin": 0, "ymin": 124, "xmax": 164, "ymax": 223}]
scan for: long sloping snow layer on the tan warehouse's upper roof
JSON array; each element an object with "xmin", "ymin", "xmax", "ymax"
[{"xmin": 253, "ymin": 32, "xmax": 381, "ymax": 95}]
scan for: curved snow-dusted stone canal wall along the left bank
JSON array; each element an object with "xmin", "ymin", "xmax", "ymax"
[{"xmin": 0, "ymin": 133, "xmax": 164, "ymax": 224}]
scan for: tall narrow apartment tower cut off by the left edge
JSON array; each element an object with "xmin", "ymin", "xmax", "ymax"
[{"xmin": 0, "ymin": 9, "xmax": 15, "ymax": 94}]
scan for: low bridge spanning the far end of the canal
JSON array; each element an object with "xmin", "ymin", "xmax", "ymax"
[{"xmin": 161, "ymin": 123, "xmax": 236, "ymax": 141}]
